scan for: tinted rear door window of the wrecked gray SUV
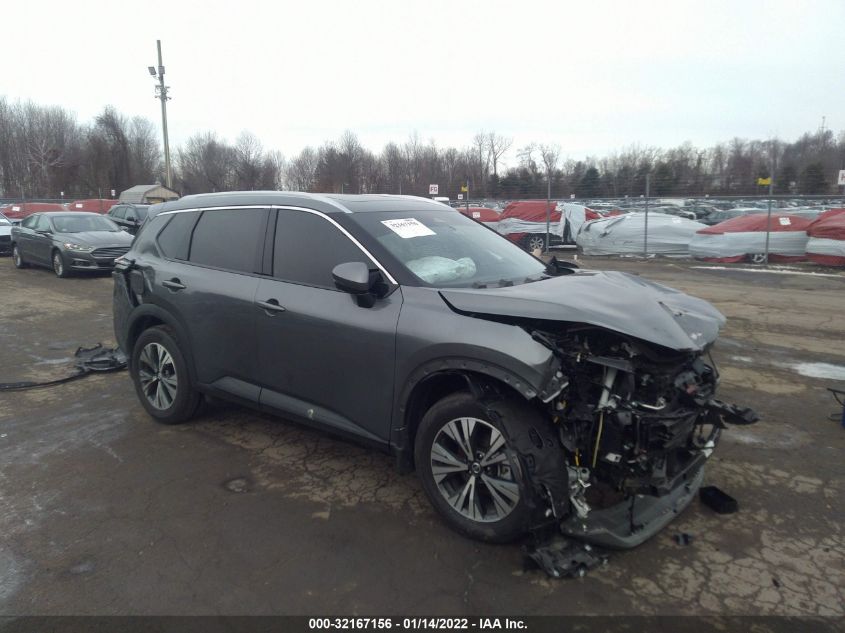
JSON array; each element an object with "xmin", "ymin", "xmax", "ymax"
[{"xmin": 189, "ymin": 209, "xmax": 267, "ymax": 273}]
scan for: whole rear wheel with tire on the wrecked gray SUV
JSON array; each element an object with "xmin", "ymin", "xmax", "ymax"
[{"xmin": 129, "ymin": 326, "xmax": 201, "ymax": 424}]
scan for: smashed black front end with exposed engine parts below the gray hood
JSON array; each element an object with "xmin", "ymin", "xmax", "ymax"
[{"xmin": 532, "ymin": 326, "xmax": 757, "ymax": 548}]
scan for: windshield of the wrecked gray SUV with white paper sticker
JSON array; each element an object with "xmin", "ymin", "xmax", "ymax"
[{"xmin": 353, "ymin": 210, "xmax": 545, "ymax": 288}]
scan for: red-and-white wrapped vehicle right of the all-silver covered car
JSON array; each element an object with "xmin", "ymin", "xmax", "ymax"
[{"xmin": 689, "ymin": 213, "xmax": 811, "ymax": 263}]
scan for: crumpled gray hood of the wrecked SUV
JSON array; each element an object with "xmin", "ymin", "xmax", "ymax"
[{"xmin": 440, "ymin": 271, "xmax": 725, "ymax": 351}]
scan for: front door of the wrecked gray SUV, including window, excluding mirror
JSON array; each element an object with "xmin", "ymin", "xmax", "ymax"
[{"xmin": 255, "ymin": 209, "xmax": 402, "ymax": 442}]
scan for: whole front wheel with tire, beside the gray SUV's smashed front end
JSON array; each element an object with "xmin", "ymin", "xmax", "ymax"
[{"xmin": 414, "ymin": 393, "xmax": 530, "ymax": 543}]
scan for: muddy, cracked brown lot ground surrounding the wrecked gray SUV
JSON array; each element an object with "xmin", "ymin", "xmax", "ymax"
[{"xmin": 0, "ymin": 258, "xmax": 845, "ymax": 615}]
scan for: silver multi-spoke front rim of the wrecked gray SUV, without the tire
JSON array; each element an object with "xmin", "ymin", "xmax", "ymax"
[{"xmin": 431, "ymin": 417, "xmax": 520, "ymax": 523}]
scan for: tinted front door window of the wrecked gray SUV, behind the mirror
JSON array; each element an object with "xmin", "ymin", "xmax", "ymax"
[{"xmin": 273, "ymin": 209, "xmax": 375, "ymax": 290}]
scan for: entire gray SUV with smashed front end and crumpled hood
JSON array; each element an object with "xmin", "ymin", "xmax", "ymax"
[{"xmin": 113, "ymin": 192, "xmax": 756, "ymax": 548}]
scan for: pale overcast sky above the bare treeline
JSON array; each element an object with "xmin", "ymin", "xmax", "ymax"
[{"xmin": 0, "ymin": 0, "xmax": 845, "ymax": 168}]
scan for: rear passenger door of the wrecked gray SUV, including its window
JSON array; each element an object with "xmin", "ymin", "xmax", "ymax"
[{"xmin": 154, "ymin": 208, "xmax": 270, "ymax": 402}]
